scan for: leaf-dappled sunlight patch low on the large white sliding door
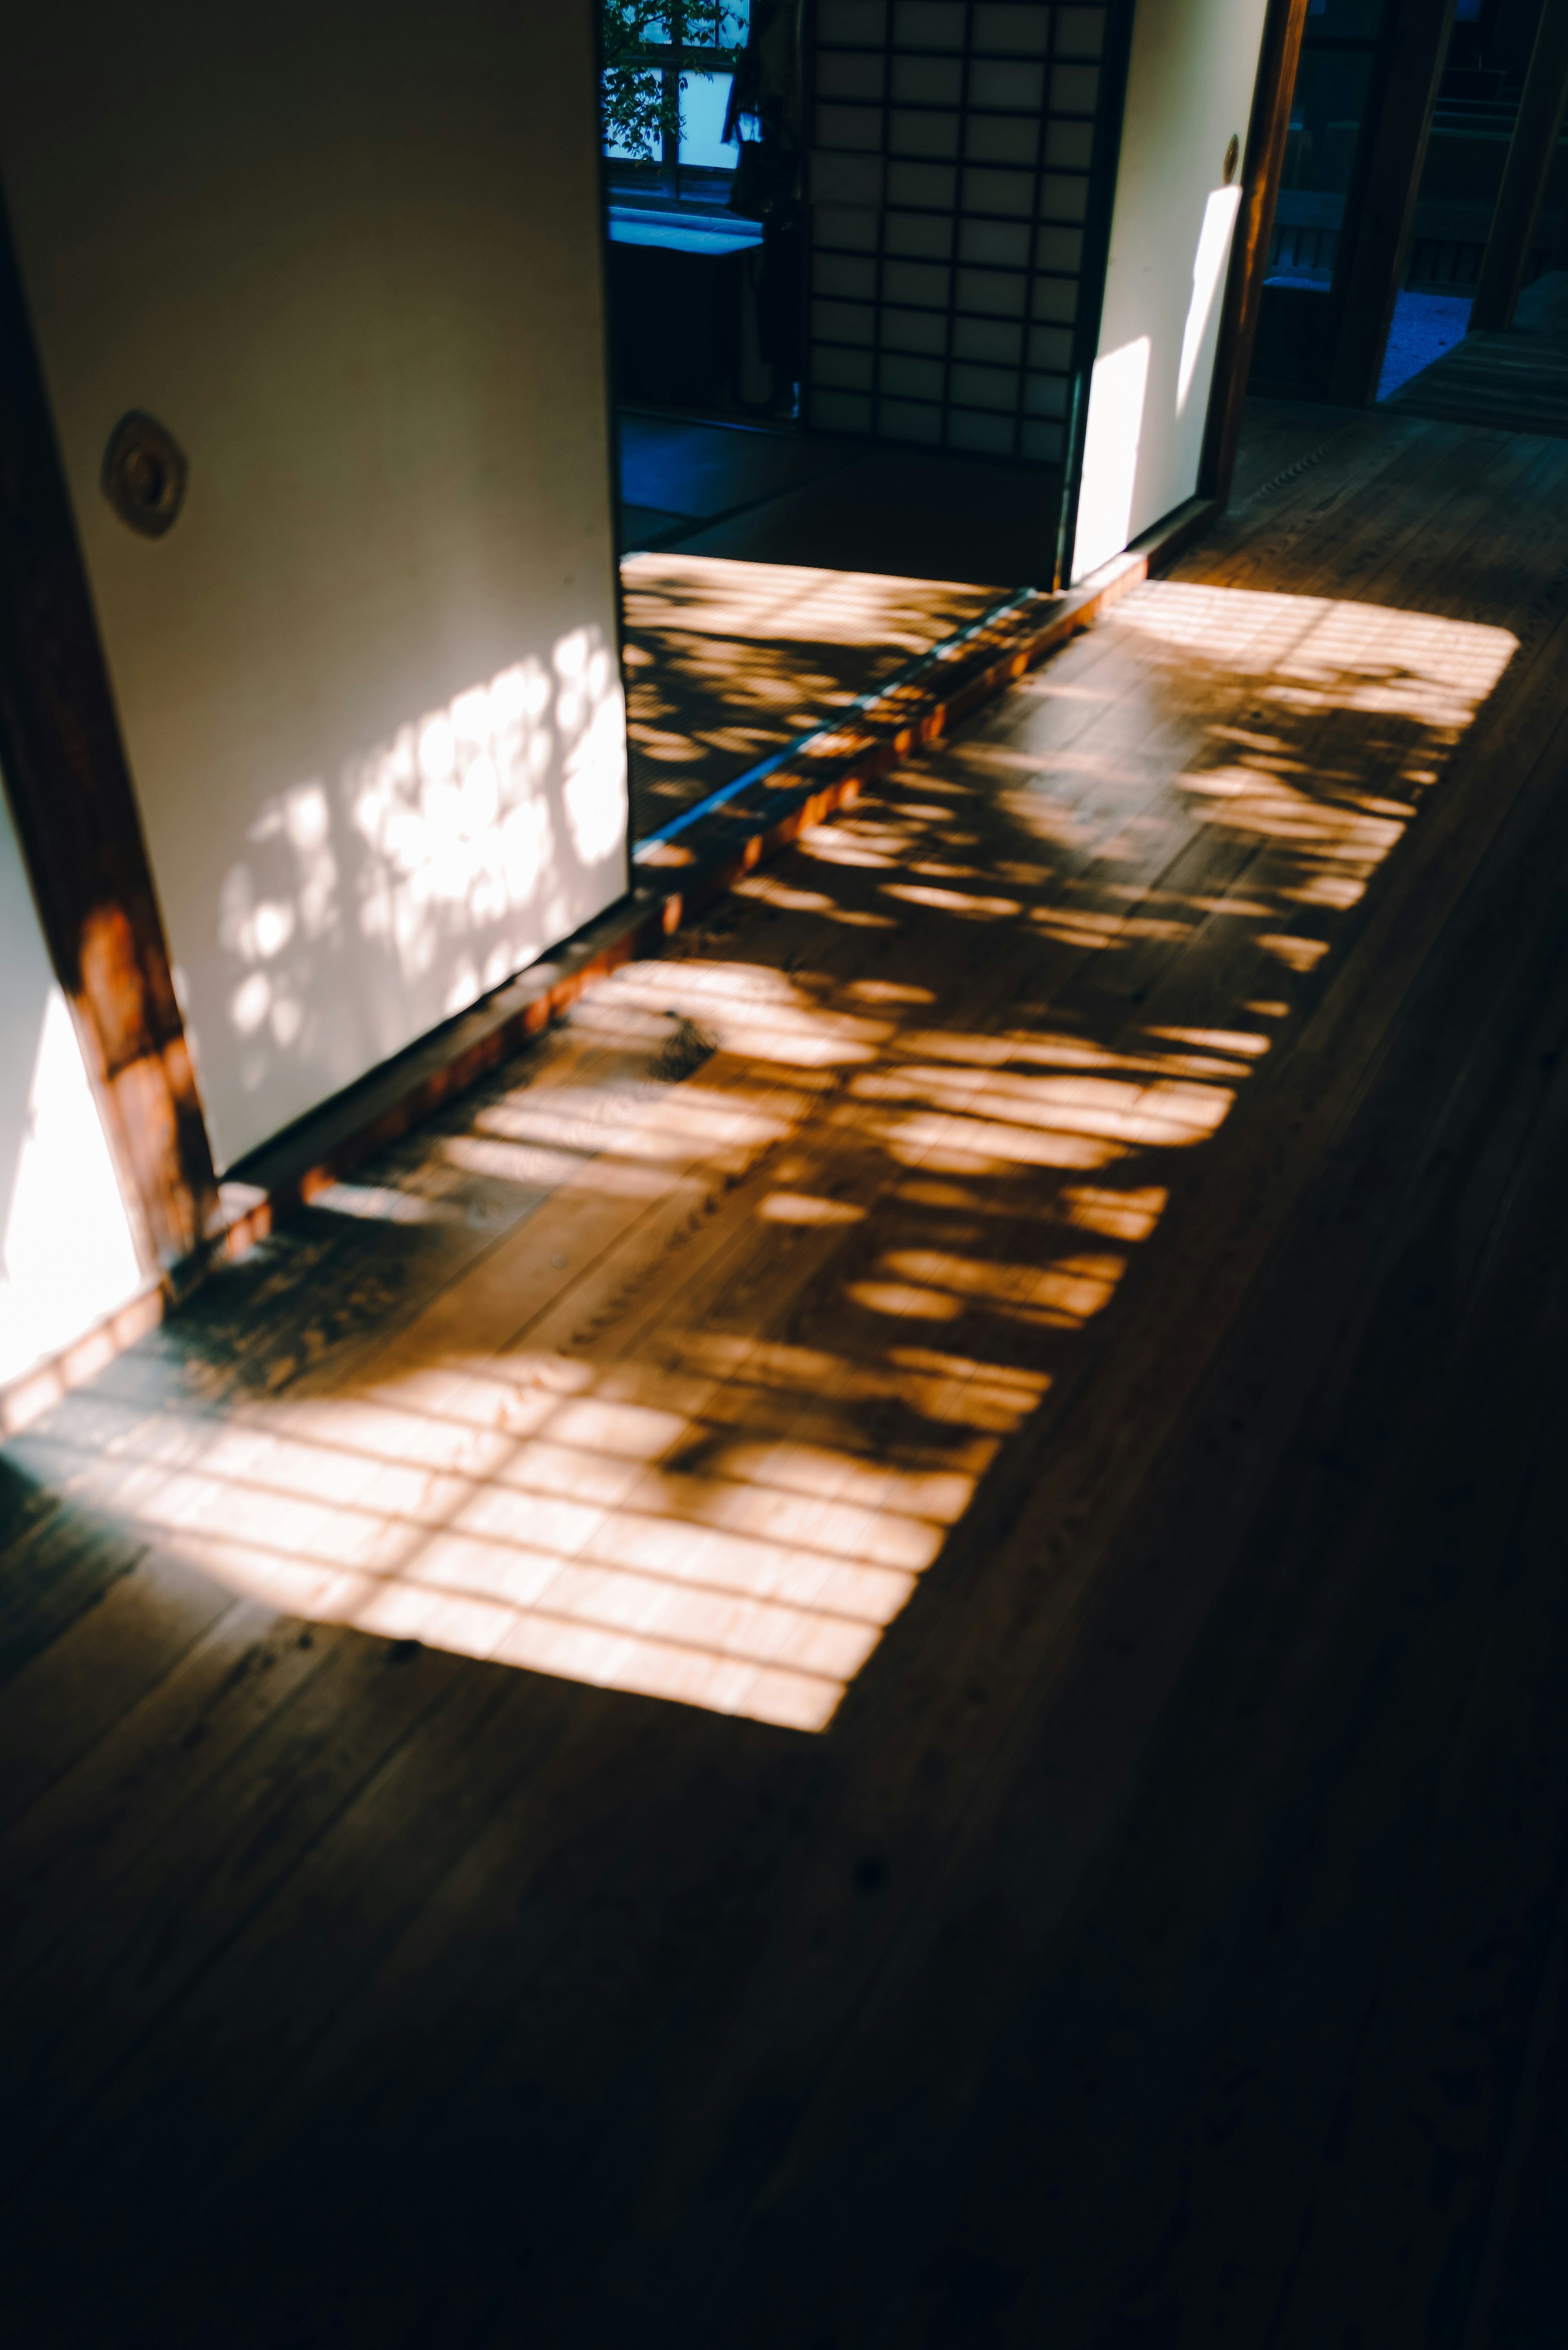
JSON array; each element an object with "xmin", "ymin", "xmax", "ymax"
[{"xmin": 207, "ymin": 625, "xmax": 628, "ymax": 1156}]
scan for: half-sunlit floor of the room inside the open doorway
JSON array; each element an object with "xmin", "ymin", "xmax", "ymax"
[{"xmin": 621, "ymin": 411, "xmax": 1072, "ymax": 839}]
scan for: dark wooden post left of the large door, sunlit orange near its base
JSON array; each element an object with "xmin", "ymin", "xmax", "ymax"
[{"xmin": 0, "ymin": 192, "xmax": 216, "ymax": 1269}]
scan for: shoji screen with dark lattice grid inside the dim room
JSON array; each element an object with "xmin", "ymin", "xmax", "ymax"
[{"xmin": 806, "ymin": 0, "xmax": 1107, "ymax": 465}]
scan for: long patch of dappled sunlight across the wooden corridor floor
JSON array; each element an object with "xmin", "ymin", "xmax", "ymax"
[{"xmin": 3, "ymin": 583, "xmax": 1514, "ymax": 1730}]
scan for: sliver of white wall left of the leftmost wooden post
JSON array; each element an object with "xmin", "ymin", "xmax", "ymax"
[{"xmin": 0, "ymin": 792, "xmax": 141, "ymax": 1384}]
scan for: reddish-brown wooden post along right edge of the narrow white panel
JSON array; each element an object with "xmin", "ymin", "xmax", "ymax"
[{"xmin": 1199, "ymin": 0, "xmax": 1310, "ymax": 505}]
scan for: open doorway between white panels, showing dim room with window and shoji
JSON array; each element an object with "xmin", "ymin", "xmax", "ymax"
[{"xmin": 599, "ymin": 0, "xmax": 1091, "ymax": 841}]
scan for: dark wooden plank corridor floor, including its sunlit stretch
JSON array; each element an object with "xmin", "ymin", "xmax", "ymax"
[{"xmin": 0, "ymin": 395, "xmax": 1568, "ymax": 2350}]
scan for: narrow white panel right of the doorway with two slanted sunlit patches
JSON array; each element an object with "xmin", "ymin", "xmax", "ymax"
[{"xmin": 1072, "ymin": 0, "xmax": 1267, "ymax": 580}]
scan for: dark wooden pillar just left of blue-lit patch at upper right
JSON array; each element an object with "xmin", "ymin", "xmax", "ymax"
[{"xmin": 1323, "ymin": 0, "xmax": 1453, "ymax": 409}]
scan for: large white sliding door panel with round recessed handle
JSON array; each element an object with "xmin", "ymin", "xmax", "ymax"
[{"xmin": 0, "ymin": 0, "xmax": 625, "ymax": 1163}]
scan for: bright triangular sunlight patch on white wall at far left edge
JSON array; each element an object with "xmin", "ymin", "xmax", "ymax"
[{"xmin": 0, "ymin": 987, "xmax": 141, "ymax": 1380}]
